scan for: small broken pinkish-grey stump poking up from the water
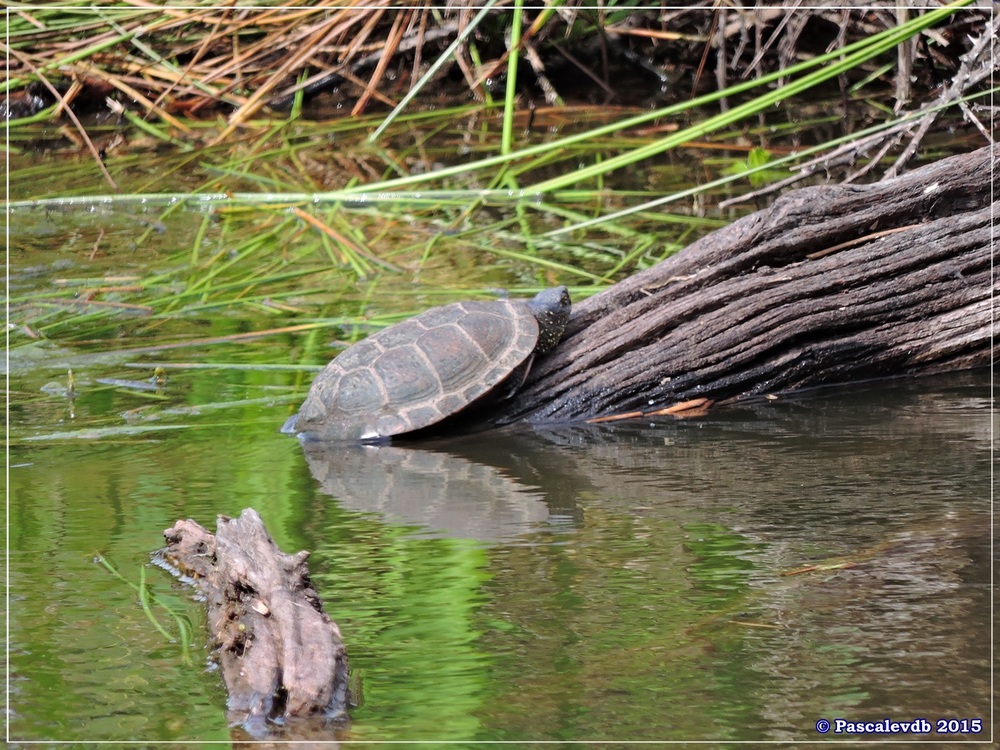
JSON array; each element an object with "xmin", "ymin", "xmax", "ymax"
[{"xmin": 162, "ymin": 509, "xmax": 348, "ymax": 736}]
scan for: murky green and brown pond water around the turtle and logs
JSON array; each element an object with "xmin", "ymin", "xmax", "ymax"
[{"xmin": 7, "ymin": 131, "xmax": 994, "ymax": 746}]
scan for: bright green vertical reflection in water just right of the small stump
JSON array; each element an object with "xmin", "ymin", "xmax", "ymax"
[{"xmin": 314, "ymin": 532, "xmax": 493, "ymax": 740}]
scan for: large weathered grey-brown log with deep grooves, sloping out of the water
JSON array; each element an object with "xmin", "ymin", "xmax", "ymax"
[{"xmin": 489, "ymin": 146, "xmax": 1000, "ymax": 423}]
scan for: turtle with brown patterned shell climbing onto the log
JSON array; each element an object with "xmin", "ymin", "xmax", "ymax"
[{"xmin": 281, "ymin": 286, "xmax": 571, "ymax": 443}]
